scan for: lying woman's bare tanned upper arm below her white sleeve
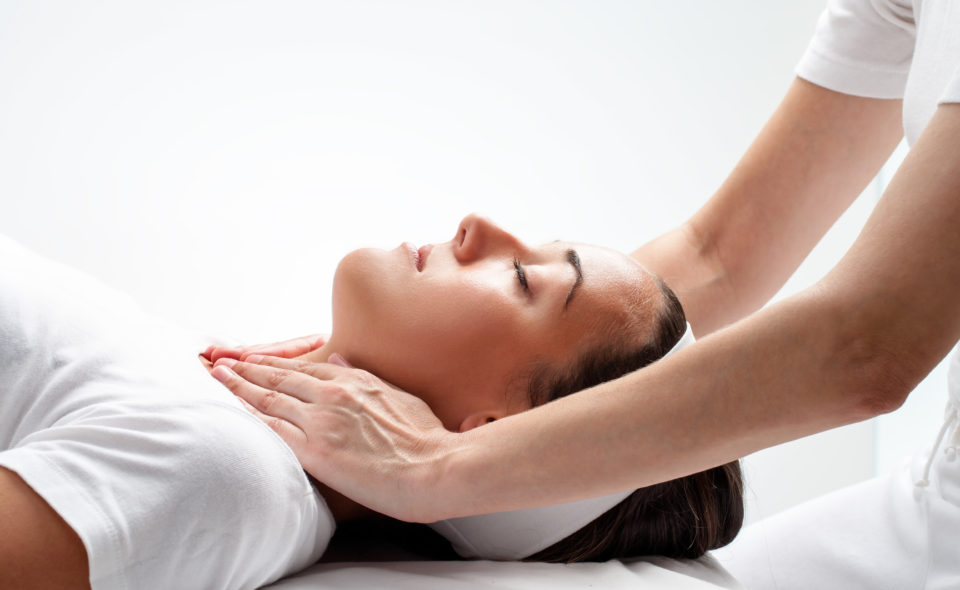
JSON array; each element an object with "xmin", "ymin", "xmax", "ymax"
[{"xmin": 0, "ymin": 467, "xmax": 90, "ymax": 590}]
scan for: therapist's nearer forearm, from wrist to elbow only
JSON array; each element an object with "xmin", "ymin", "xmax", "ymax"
[{"xmin": 451, "ymin": 292, "xmax": 860, "ymax": 512}]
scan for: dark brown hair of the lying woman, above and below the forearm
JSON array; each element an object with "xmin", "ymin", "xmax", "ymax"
[{"xmin": 527, "ymin": 277, "xmax": 743, "ymax": 562}]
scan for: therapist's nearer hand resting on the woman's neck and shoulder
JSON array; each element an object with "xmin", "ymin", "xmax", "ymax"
[{"xmin": 212, "ymin": 355, "xmax": 457, "ymax": 522}]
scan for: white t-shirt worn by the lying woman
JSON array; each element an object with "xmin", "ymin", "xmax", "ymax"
[{"xmin": 0, "ymin": 236, "xmax": 334, "ymax": 590}]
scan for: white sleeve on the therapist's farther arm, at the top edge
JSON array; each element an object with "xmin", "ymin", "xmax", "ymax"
[{"xmin": 796, "ymin": 0, "xmax": 916, "ymax": 98}]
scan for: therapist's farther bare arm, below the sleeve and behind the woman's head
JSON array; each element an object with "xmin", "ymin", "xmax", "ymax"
[{"xmin": 633, "ymin": 78, "xmax": 902, "ymax": 337}]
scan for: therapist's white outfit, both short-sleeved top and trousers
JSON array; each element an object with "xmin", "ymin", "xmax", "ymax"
[{"xmin": 714, "ymin": 0, "xmax": 960, "ymax": 590}]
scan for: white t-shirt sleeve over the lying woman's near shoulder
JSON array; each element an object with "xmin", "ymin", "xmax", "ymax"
[{"xmin": 0, "ymin": 400, "xmax": 334, "ymax": 590}]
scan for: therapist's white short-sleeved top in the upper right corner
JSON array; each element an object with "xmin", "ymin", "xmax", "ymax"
[{"xmin": 797, "ymin": 0, "xmax": 960, "ymax": 145}]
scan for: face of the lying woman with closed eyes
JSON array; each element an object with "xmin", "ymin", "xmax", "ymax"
[{"xmin": 330, "ymin": 215, "xmax": 661, "ymax": 430}]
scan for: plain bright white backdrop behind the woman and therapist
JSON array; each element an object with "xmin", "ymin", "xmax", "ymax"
[{"xmin": 0, "ymin": 0, "xmax": 944, "ymax": 519}]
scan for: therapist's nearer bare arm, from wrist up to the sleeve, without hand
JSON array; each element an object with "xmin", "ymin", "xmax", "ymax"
[{"xmin": 441, "ymin": 105, "xmax": 960, "ymax": 513}]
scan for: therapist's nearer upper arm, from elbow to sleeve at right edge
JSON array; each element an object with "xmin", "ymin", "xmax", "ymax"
[{"xmin": 817, "ymin": 104, "xmax": 960, "ymax": 411}]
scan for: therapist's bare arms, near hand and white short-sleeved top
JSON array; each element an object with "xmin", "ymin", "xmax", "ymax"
[{"xmin": 212, "ymin": 0, "xmax": 960, "ymax": 588}]
